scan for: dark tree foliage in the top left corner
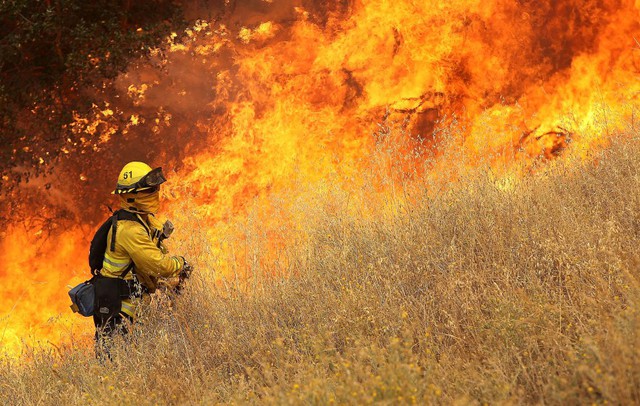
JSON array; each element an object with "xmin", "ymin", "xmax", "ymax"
[{"xmin": 0, "ymin": 0, "xmax": 183, "ymax": 192}]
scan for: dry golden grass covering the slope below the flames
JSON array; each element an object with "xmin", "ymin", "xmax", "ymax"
[{"xmin": 0, "ymin": 127, "xmax": 640, "ymax": 405}]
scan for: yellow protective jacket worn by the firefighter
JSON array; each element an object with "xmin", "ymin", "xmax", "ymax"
[{"xmin": 100, "ymin": 214, "xmax": 184, "ymax": 317}]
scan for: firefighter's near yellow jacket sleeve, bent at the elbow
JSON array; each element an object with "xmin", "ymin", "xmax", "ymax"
[{"xmin": 121, "ymin": 225, "xmax": 184, "ymax": 278}]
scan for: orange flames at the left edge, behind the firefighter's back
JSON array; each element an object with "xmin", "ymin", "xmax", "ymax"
[{"xmin": 0, "ymin": 227, "xmax": 88, "ymax": 353}]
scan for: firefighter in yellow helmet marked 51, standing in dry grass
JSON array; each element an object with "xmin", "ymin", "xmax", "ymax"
[{"xmin": 90, "ymin": 162, "xmax": 190, "ymax": 355}]
